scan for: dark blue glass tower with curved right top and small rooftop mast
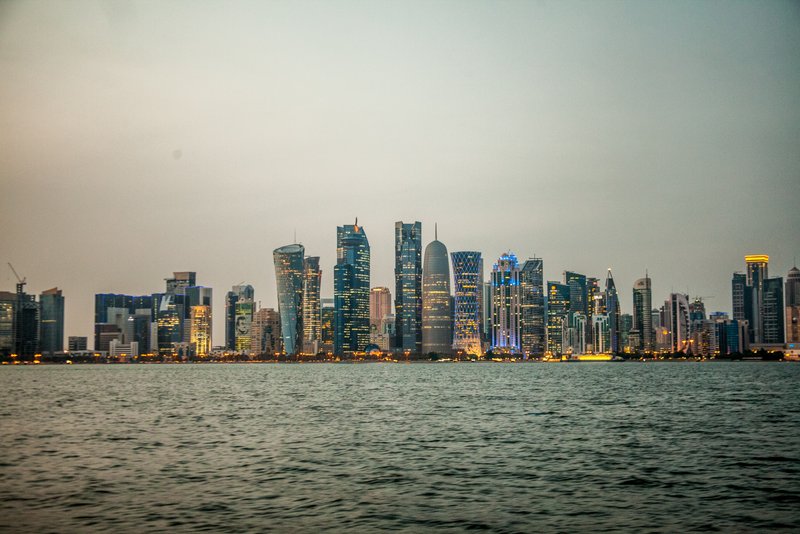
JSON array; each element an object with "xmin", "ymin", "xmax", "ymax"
[{"xmin": 333, "ymin": 219, "xmax": 370, "ymax": 355}]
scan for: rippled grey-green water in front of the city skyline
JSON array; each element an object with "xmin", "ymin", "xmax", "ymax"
[{"xmin": 0, "ymin": 362, "xmax": 800, "ymax": 532}]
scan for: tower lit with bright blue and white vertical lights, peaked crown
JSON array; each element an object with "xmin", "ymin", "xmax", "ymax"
[{"xmin": 492, "ymin": 252, "xmax": 522, "ymax": 354}]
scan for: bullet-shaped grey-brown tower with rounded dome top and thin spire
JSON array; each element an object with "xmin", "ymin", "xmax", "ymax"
[{"xmin": 422, "ymin": 236, "xmax": 453, "ymax": 354}]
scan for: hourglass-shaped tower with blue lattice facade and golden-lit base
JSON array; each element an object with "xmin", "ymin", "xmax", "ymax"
[{"xmin": 450, "ymin": 251, "xmax": 483, "ymax": 356}]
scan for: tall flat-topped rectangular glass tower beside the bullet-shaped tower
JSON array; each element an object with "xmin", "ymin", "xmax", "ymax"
[{"xmin": 394, "ymin": 221, "xmax": 422, "ymax": 352}]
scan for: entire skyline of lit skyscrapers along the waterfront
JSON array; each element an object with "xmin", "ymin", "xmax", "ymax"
[{"xmin": 0, "ymin": 224, "xmax": 800, "ymax": 359}]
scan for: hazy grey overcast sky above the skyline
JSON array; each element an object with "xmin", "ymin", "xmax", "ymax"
[{"xmin": 0, "ymin": 1, "xmax": 800, "ymax": 345}]
